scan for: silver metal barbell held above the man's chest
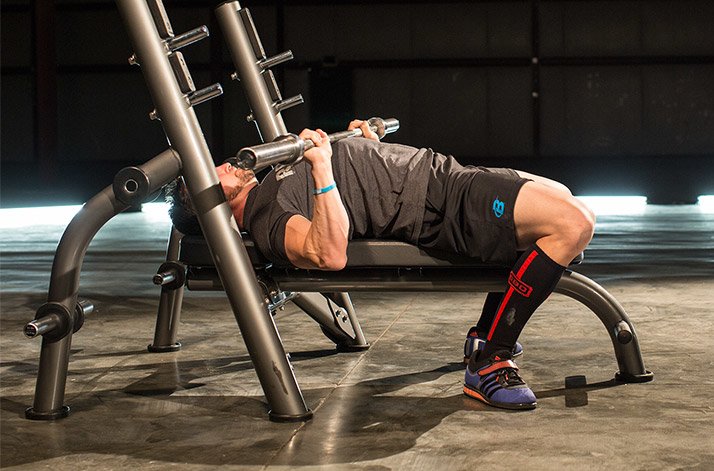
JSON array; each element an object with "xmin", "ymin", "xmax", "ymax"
[{"xmin": 236, "ymin": 118, "xmax": 399, "ymax": 171}]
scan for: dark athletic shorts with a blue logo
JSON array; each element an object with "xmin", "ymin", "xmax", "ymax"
[{"xmin": 418, "ymin": 155, "xmax": 529, "ymax": 265}]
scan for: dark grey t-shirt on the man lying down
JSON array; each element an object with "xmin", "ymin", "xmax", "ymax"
[{"xmin": 243, "ymin": 138, "xmax": 434, "ymax": 262}]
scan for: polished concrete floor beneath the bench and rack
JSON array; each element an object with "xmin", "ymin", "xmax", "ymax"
[{"xmin": 0, "ymin": 201, "xmax": 714, "ymax": 470}]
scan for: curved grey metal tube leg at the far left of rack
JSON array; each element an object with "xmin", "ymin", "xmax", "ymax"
[{"xmin": 25, "ymin": 149, "xmax": 180, "ymax": 420}]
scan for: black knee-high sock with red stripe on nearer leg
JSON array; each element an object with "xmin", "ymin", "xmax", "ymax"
[{"xmin": 480, "ymin": 244, "xmax": 565, "ymax": 359}]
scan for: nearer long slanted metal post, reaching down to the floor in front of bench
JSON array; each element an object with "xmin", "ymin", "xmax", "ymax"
[{"xmin": 117, "ymin": 0, "xmax": 312, "ymax": 421}]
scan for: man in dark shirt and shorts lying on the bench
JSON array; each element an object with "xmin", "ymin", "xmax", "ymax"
[{"xmin": 164, "ymin": 120, "xmax": 595, "ymax": 409}]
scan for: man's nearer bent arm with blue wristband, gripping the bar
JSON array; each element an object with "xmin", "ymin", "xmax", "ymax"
[{"xmin": 285, "ymin": 129, "xmax": 349, "ymax": 270}]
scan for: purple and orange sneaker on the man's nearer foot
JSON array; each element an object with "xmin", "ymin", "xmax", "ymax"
[{"xmin": 464, "ymin": 350, "xmax": 536, "ymax": 409}]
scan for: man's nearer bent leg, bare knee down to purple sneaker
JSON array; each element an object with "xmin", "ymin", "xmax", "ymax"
[{"xmin": 464, "ymin": 181, "xmax": 595, "ymax": 408}]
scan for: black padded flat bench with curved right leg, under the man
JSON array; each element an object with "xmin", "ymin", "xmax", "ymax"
[{"xmin": 157, "ymin": 234, "xmax": 652, "ymax": 388}]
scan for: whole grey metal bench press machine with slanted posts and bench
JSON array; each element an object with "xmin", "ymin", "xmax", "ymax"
[{"xmin": 25, "ymin": 0, "xmax": 652, "ymax": 421}]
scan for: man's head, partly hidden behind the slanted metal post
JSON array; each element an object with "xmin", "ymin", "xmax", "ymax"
[{"xmin": 164, "ymin": 162, "xmax": 258, "ymax": 234}]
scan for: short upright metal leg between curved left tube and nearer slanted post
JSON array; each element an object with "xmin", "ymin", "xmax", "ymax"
[{"xmin": 147, "ymin": 227, "xmax": 184, "ymax": 353}]
